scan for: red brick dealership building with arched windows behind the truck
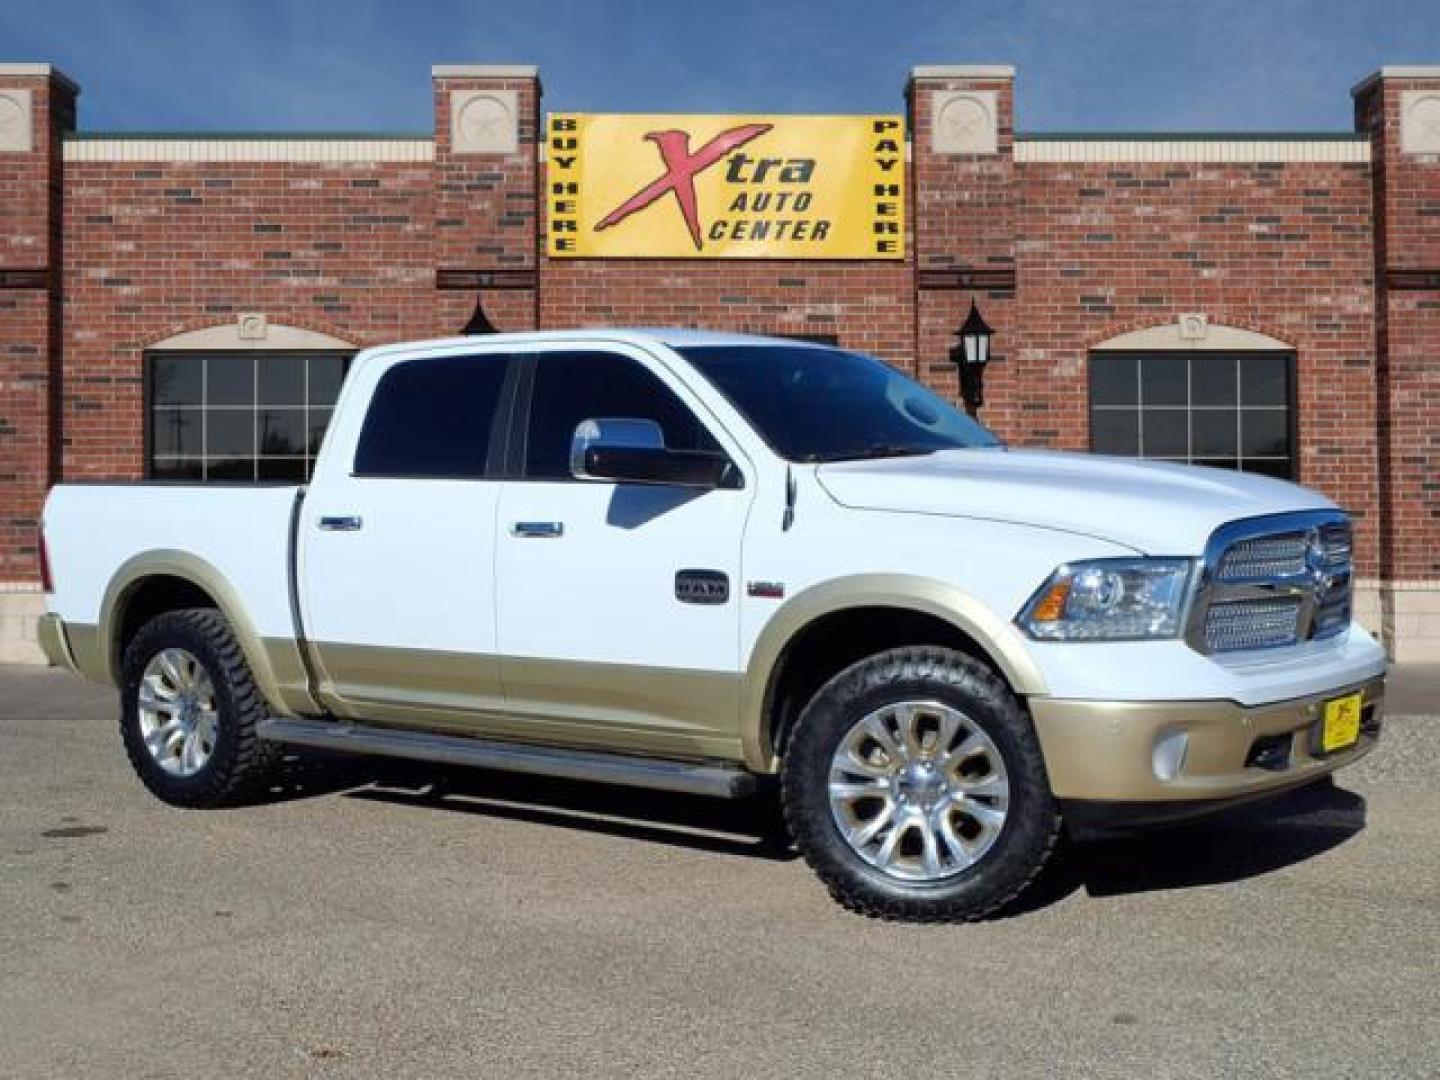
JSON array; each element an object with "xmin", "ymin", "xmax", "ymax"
[{"xmin": 0, "ymin": 63, "xmax": 1440, "ymax": 658}]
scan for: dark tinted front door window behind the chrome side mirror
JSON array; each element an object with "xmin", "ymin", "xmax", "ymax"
[{"xmin": 526, "ymin": 353, "xmax": 720, "ymax": 480}]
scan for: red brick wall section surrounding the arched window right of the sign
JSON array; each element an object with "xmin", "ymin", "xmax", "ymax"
[{"xmin": 1008, "ymin": 163, "xmax": 1378, "ymax": 576}]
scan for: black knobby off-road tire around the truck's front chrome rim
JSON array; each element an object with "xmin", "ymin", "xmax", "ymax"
[{"xmin": 782, "ymin": 647, "xmax": 1060, "ymax": 923}]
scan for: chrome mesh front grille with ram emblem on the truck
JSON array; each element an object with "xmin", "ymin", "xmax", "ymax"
[{"xmin": 1185, "ymin": 511, "xmax": 1352, "ymax": 652}]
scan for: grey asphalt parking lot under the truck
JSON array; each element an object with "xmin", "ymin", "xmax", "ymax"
[{"xmin": 0, "ymin": 668, "xmax": 1440, "ymax": 1077}]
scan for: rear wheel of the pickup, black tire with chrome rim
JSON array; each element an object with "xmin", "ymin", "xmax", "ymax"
[{"xmin": 120, "ymin": 608, "xmax": 279, "ymax": 806}]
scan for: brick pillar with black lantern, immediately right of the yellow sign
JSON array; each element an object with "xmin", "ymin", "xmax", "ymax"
[{"xmin": 907, "ymin": 65, "xmax": 1025, "ymax": 429}]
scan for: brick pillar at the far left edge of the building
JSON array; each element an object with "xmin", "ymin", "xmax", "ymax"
[{"xmin": 0, "ymin": 63, "xmax": 79, "ymax": 661}]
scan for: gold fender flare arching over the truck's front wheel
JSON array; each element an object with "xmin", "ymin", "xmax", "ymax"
[{"xmin": 740, "ymin": 573, "xmax": 1048, "ymax": 772}]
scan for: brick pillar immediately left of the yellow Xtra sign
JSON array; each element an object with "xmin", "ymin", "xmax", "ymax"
[{"xmin": 431, "ymin": 65, "xmax": 540, "ymax": 334}]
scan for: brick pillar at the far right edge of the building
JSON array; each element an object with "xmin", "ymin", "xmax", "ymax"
[{"xmin": 1354, "ymin": 66, "xmax": 1440, "ymax": 660}]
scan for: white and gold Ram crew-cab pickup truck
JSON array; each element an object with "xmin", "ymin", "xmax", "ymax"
[{"xmin": 40, "ymin": 330, "xmax": 1385, "ymax": 920}]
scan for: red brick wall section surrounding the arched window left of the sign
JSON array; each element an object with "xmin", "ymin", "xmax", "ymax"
[{"xmin": 63, "ymin": 161, "xmax": 437, "ymax": 478}]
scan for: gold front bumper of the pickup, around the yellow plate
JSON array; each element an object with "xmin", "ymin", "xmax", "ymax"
[{"xmin": 1030, "ymin": 677, "xmax": 1385, "ymax": 822}]
